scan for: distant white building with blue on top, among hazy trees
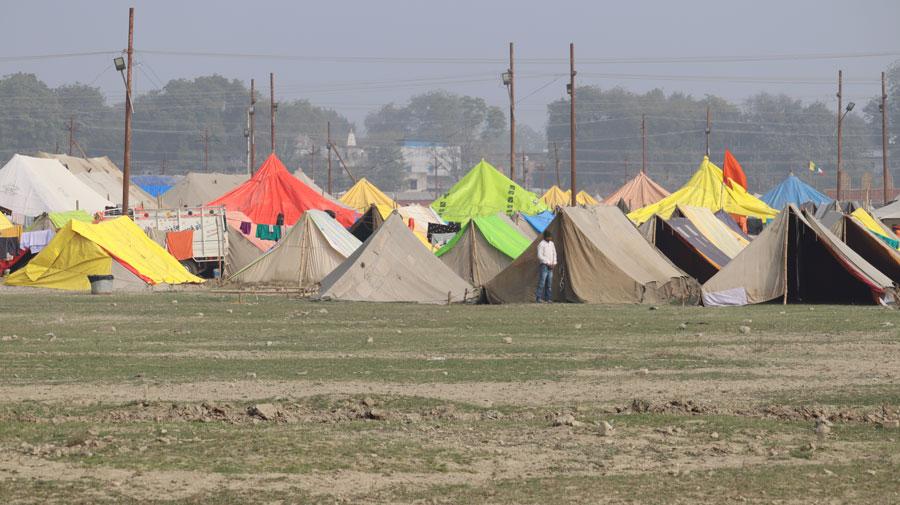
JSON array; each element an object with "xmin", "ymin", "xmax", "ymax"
[{"xmin": 400, "ymin": 140, "xmax": 462, "ymax": 194}]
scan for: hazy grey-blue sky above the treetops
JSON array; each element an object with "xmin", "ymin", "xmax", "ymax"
[{"xmin": 0, "ymin": 0, "xmax": 900, "ymax": 129}]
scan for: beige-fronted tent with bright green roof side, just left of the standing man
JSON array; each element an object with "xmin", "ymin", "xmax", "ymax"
[{"xmin": 435, "ymin": 213, "xmax": 531, "ymax": 286}]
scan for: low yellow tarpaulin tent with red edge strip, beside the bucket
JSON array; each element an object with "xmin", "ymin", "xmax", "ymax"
[{"xmin": 6, "ymin": 217, "xmax": 203, "ymax": 291}]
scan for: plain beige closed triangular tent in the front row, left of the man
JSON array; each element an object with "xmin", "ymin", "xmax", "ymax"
[{"xmin": 318, "ymin": 213, "xmax": 474, "ymax": 303}]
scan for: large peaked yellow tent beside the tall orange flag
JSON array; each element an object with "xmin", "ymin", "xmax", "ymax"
[{"xmin": 628, "ymin": 156, "xmax": 778, "ymax": 224}]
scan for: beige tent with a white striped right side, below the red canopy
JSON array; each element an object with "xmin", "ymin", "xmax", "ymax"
[{"xmin": 228, "ymin": 210, "xmax": 360, "ymax": 289}]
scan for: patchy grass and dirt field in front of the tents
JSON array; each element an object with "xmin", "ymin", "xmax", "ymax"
[{"xmin": 0, "ymin": 291, "xmax": 900, "ymax": 504}]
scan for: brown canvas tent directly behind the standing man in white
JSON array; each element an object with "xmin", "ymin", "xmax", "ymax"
[{"xmin": 484, "ymin": 206, "xmax": 700, "ymax": 303}]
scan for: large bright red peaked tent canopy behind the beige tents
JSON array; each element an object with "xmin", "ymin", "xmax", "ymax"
[{"xmin": 207, "ymin": 153, "xmax": 358, "ymax": 227}]
